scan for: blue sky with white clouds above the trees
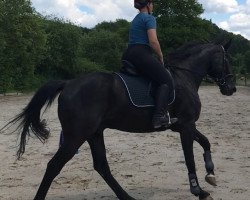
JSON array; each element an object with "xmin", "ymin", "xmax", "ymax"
[{"xmin": 31, "ymin": 0, "xmax": 250, "ymax": 40}]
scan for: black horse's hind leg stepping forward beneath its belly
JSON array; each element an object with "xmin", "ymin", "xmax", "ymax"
[{"xmin": 88, "ymin": 131, "xmax": 135, "ymax": 200}]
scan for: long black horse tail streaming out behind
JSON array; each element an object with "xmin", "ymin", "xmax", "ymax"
[{"xmin": 0, "ymin": 81, "xmax": 66, "ymax": 159}]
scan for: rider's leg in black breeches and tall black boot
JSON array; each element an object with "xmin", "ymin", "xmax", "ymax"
[{"xmin": 123, "ymin": 45, "xmax": 177, "ymax": 128}]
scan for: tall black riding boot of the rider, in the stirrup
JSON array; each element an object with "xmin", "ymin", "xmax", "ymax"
[{"xmin": 152, "ymin": 84, "xmax": 178, "ymax": 129}]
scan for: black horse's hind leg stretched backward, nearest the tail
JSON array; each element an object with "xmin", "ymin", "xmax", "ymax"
[{"xmin": 34, "ymin": 138, "xmax": 84, "ymax": 200}]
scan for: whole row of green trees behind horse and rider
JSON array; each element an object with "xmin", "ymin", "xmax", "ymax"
[{"xmin": 0, "ymin": 0, "xmax": 250, "ymax": 93}]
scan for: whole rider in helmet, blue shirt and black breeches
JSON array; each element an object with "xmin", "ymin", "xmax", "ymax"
[{"xmin": 122, "ymin": 0, "xmax": 177, "ymax": 128}]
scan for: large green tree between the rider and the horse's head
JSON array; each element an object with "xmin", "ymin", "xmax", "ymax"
[{"xmin": 154, "ymin": 0, "xmax": 213, "ymax": 52}]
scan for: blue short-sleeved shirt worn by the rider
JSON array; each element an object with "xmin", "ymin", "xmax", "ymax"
[{"xmin": 129, "ymin": 12, "xmax": 156, "ymax": 45}]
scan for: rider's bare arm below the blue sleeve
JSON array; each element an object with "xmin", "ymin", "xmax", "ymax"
[{"xmin": 148, "ymin": 29, "xmax": 164, "ymax": 64}]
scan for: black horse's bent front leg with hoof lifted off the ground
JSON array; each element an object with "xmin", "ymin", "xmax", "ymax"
[{"xmin": 194, "ymin": 129, "xmax": 217, "ymax": 186}]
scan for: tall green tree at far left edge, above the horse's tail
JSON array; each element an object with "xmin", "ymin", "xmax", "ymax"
[{"xmin": 0, "ymin": 0, "xmax": 45, "ymax": 92}]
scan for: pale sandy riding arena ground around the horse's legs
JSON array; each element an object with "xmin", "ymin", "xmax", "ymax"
[{"xmin": 0, "ymin": 86, "xmax": 250, "ymax": 200}]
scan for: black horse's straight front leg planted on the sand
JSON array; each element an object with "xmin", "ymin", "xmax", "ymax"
[{"xmin": 180, "ymin": 124, "xmax": 213, "ymax": 200}]
